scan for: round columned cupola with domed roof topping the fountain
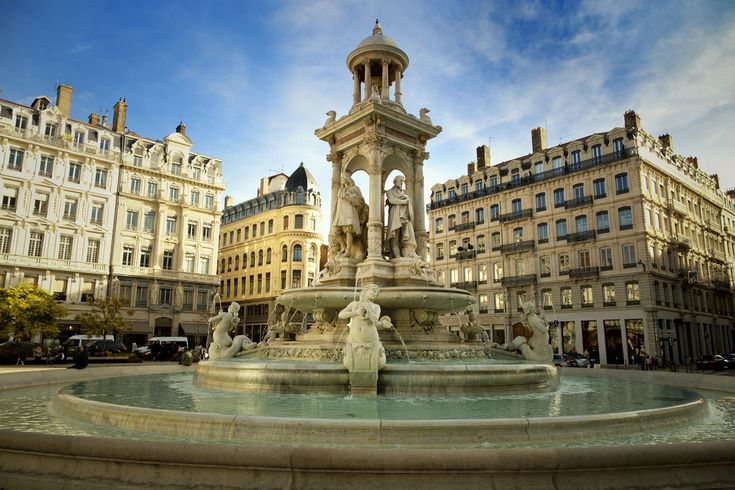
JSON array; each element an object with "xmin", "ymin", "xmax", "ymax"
[{"xmin": 347, "ymin": 19, "xmax": 408, "ymax": 109}]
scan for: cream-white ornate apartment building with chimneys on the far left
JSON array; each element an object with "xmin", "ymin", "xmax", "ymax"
[{"xmin": 0, "ymin": 84, "xmax": 224, "ymax": 340}]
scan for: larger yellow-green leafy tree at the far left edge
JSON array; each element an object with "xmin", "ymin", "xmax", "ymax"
[{"xmin": 0, "ymin": 283, "xmax": 69, "ymax": 340}]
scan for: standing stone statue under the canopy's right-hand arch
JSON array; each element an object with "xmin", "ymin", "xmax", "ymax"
[{"xmin": 385, "ymin": 175, "xmax": 418, "ymax": 258}]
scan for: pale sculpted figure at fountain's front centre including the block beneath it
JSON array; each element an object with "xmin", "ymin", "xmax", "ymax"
[{"xmin": 339, "ymin": 284, "xmax": 393, "ymax": 393}]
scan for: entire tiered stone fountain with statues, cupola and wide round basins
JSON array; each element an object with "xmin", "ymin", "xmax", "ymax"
[{"xmin": 0, "ymin": 22, "xmax": 735, "ymax": 488}]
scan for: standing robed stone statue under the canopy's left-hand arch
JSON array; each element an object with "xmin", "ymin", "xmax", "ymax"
[{"xmin": 332, "ymin": 175, "xmax": 368, "ymax": 260}]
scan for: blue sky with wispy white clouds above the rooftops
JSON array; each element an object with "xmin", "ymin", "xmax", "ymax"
[{"xmin": 0, "ymin": 0, "xmax": 735, "ymax": 235}]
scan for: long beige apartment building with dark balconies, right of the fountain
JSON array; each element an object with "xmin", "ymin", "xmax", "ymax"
[{"xmin": 427, "ymin": 111, "xmax": 735, "ymax": 364}]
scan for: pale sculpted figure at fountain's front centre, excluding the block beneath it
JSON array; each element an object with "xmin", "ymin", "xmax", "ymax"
[{"xmin": 339, "ymin": 284, "xmax": 393, "ymax": 372}]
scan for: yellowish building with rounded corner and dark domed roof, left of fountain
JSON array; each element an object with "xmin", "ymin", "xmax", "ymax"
[{"xmin": 219, "ymin": 163, "xmax": 323, "ymax": 341}]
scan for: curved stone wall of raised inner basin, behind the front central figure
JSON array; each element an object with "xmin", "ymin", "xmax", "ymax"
[{"xmin": 194, "ymin": 358, "xmax": 559, "ymax": 395}]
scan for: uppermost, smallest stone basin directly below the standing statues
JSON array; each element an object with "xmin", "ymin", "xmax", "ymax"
[{"xmin": 278, "ymin": 286, "xmax": 474, "ymax": 314}]
